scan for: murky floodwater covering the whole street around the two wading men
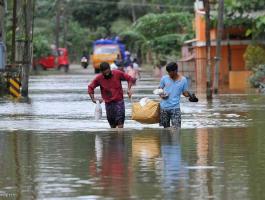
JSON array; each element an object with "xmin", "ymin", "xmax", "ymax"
[{"xmin": 0, "ymin": 66, "xmax": 265, "ymax": 200}]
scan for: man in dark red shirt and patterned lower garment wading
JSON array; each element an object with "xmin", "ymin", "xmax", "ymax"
[{"xmin": 88, "ymin": 62, "xmax": 134, "ymax": 128}]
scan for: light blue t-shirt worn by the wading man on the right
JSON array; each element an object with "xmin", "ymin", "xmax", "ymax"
[{"xmin": 159, "ymin": 75, "xmax": 188, "ymax": 109}]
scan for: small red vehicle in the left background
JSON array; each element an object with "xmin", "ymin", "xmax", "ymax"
[{"xmin": 33, "ymin": 48, "xmax": 69, "ymax": 72}]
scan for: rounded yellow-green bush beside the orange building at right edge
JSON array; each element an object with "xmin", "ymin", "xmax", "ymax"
[{"xmin": 244, "ymin": 45, "xmax": 265, "ymax": 70}]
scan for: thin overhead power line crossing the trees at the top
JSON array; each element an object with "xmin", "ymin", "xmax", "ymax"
[{"xmin": 77, "ymin": 0, "xmax": 193, "ymax": 10}]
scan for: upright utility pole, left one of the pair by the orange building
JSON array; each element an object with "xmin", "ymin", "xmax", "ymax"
[{"xmin": 203, "ymin": 0, "xmax": 213, "ymax": 100}]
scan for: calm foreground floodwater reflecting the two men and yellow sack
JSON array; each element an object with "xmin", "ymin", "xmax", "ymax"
[{"xmin": 0, "ymin": 126, "xmax": 265, "ymax": 200}]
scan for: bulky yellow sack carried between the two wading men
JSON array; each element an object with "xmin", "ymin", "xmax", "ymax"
[{"xmin": 132, "ymin": 100, "xmax": 160, "ymax": 124}]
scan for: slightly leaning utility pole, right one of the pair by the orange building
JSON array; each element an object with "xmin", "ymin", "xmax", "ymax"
[{"xmin": 213, "ymin": 0, "xmax": 224, "ymax": 94}]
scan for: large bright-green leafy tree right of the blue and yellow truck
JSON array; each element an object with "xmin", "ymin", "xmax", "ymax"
[{"xmin": 120, "ymin": 13, "xmax": 193, "ymax": 60}]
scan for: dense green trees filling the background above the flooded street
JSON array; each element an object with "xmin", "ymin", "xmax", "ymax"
[{"xmin": 3, "ymin": 0, "xmax": 265, "ymax": 65}]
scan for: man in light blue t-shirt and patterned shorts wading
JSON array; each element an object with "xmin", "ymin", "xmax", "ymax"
[{"xmin": 159, "ymin": 62, "xmax": 198, "ymax": 128}]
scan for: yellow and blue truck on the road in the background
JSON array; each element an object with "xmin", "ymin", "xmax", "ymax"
[{"xmin": 91, "ymin": 39, "xmax": 125, "ymax": 73}]
